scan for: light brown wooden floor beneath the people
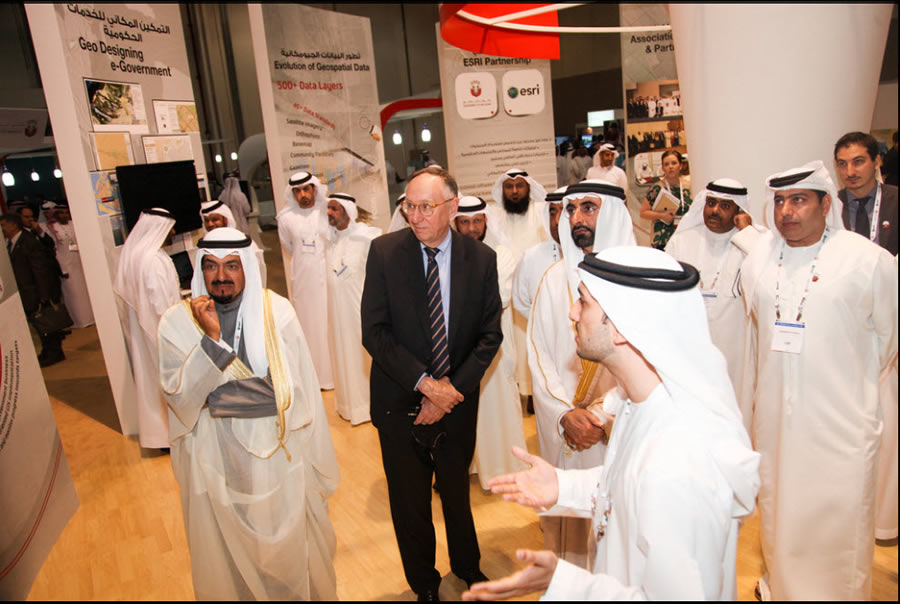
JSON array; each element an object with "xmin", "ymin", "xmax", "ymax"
[{"xmin": 28, "ymin": 231, "xmax": 897, "ymax": 601}]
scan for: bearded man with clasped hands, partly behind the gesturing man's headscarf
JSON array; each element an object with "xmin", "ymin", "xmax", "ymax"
[{"xmin": 528, "ymin": 181, "xmax": 635, "ymax": 568}]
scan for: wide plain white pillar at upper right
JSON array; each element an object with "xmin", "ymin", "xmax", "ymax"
[{"xmin": 669, "ymin": 4, "xmax": 893, "ymax": 221}]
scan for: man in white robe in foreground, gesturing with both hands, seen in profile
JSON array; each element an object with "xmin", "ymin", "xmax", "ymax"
[{"xmin": 463, "ymin": 246, "xmax": 760, "ymax": 601}]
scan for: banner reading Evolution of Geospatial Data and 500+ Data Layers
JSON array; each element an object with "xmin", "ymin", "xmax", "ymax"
[{"xmin": 248, "ymin": 4, "xmax": 390, "ymax": 230}]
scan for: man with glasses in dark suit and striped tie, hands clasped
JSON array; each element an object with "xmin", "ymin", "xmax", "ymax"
[{"xmin": 361, "ymin": 166, "xmax": 503, "ymax": 601}]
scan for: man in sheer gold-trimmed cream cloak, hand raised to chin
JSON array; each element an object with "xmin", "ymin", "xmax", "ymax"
[{"xmin": 159, "ymin": 228, "xmax": 339, "ymax": 600}]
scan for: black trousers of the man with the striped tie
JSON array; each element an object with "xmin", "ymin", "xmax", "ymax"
[{"xmin": 378, "ymin": 402, "xmax": 481, "ymax": 594}]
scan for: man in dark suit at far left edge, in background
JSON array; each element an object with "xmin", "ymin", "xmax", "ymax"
[{"xmin": 0, "ymin": 214, "xmax": 66, "ymax": 367}]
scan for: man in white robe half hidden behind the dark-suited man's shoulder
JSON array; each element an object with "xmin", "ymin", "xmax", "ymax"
[{"xmin": 454, "ymin": 195, "xmax": 525, "ymax": 489}]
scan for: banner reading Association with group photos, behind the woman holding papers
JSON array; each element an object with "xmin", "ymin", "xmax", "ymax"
[{"xmin": 619, "ymin": 4, "xmax": 690, "ymax": 244}]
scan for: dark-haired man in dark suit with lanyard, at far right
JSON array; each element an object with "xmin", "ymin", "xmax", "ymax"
[{"xmin": 834, "ymin": 132, "xmax": 898, "ymax": 256}]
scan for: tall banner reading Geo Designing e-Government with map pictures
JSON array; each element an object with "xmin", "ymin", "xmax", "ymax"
[{"xmin": 25, "ymin": 3, "xmax": 208, "ymax": 435}]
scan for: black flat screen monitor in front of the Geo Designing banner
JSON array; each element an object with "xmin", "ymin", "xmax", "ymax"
[{"xmin": 116, "ymin": 160, "xmax": 203, "ymax": 233}]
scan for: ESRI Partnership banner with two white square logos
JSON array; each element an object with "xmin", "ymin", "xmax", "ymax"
[{"xmin": 436, "ymin": 26, "xmax": 556, "ymax": 201}]
